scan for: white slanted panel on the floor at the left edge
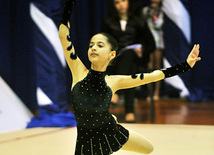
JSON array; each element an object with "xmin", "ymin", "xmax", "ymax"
[{"xmin": 0, "ymin": 76, "xmax": 32, "ymax": 134}]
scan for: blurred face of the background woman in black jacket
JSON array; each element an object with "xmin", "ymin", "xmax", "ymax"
[{"xmin": 114, "ymin": 0, "xmax": 129, "ymax": 14}]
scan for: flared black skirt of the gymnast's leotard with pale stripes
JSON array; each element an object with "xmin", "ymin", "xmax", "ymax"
[{"xmin": 75, "ymin": 118, "xmax": 129, "ymax": 155}]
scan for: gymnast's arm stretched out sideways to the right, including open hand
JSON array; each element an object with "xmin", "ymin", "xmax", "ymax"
[{"xmin": 108, "ymin": 44, "xmax": 201, "ymax": 92}]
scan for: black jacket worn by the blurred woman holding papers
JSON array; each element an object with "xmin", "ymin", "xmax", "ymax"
[{"xmin": 101, "ymin": 16, "xmax": 155, "ymax": 55}]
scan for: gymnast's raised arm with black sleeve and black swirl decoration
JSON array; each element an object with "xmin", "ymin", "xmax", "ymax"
[{"xmin": 59, "ymin": 0, "xmax": 88, "ymax": 87}]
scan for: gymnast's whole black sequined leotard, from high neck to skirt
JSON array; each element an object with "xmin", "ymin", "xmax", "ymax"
[{"xmin": 72, "ymin": 70, "xmax": 129, "ymax": 155}]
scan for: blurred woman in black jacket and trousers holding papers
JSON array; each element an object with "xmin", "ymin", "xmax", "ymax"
[{"xmin": 101, "ymin": 0, "xmax": 155, "ymax": 122}]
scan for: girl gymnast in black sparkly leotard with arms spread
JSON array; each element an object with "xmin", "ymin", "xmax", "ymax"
[{"xmin": 59, "ymin": 0, "xmax": 200, "ymax": 155}]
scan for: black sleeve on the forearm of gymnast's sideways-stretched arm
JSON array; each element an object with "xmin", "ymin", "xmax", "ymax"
[{"xmin": 161, "ymin": 62, "xmax": 191, "ymax": 78}]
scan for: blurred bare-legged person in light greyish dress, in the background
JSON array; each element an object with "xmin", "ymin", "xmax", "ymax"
[{"xmin": 142, "ymin": 0, "xmax": 164, "ymax": 100}]
